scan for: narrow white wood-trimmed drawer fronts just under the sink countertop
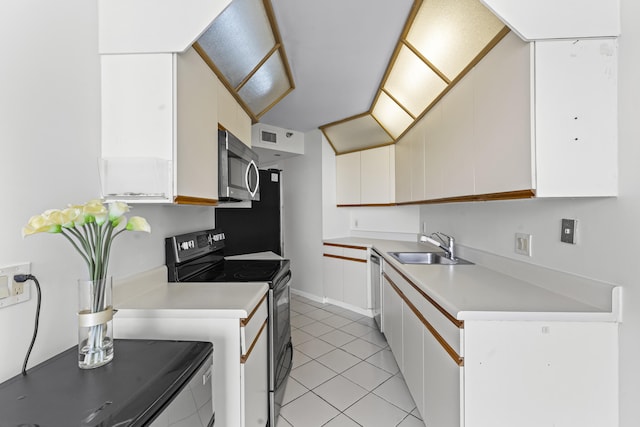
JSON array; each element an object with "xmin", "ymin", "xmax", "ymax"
[{"xmin": 385, "ymin": 267, "xmax": 463, "ymax": 363}]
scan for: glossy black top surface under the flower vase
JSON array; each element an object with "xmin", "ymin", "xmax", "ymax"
[{"xmin": 0, "ymin": 340, "xmax": 213, "ymax": 427}]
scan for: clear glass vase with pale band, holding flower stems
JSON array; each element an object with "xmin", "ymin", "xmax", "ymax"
[{"xmin": 78, "ymin": 277, "xmax": 113, "ymax": 369}]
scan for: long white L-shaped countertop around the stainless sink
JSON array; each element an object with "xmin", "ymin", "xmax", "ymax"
[{"xmin": 324, "ymin": 237, "xmax": 620, "ymax": 321}]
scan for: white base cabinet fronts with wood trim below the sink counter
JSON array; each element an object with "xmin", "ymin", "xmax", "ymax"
[{"xmin": 382, "ymin": 268, "xmax": 463, "ymax": 426}]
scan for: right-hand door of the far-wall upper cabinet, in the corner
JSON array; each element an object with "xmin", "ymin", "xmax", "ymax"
[{"xmin": 360, "ymin": 146, "xmax": 395, "ymax": 205}]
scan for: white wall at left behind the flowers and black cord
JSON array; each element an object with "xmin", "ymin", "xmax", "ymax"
[{"xmin": 0, "ymin": 0, "xmax": 214, "ymax": 382}]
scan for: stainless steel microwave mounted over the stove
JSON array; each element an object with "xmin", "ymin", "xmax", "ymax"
[{"xmin": 218, "ymin": 130, "xmax": 260, "ymax": 202}]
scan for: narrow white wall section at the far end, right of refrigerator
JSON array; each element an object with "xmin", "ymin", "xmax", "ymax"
[{"xmin": 280, "ymin": 131, "xmax": 322, "ymax": 296}]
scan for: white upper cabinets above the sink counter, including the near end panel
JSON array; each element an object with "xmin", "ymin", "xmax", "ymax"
[{"xmin": 397, "ymin": 34, "xmax": 617, "ymax": 203}]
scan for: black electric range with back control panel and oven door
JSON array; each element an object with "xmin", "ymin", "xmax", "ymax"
[{"xmin": 165, "ymin": 228, "xmax": 293, "ymax": 427}]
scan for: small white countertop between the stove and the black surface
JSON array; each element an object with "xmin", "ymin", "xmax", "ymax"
[{"xmin": 113, "ymin": 266, "xmax": 269, "ymax": 318}]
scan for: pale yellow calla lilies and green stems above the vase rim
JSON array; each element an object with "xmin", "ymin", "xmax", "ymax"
[{"xmin": 22, "ymin": 200, "xmax": 151, "ymax": 280}]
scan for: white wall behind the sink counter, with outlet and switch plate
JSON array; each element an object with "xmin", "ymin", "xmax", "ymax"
[{"xmin": 421, "ymin": 0, "xmax": 640, "ymax": 427}]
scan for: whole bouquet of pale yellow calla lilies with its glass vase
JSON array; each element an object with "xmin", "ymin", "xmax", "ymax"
[{"xmin": 22, "ymin": 200, "xmax": 151, "ymax": 369}]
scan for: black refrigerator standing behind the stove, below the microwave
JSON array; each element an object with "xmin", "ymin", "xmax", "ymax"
[{"xmin": 215, "ymin": 169, "xmax": 282, "ymax": 255}]
